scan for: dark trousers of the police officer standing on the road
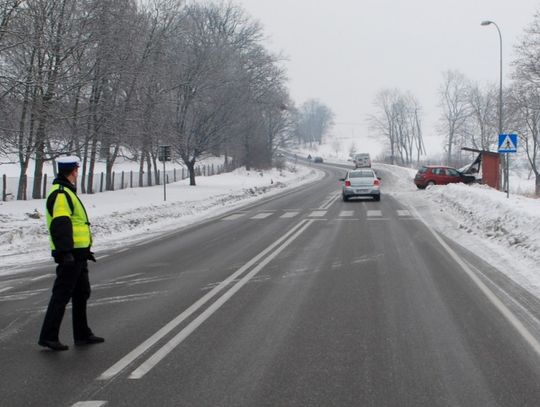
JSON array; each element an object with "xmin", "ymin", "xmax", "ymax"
[{"xmin": 39, "ymin": 259, "xmax": 92, "ymax": 341}]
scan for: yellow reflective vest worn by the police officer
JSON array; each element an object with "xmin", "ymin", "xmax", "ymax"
[{"xmin": 45, "ymin": 184, "xmax": 92, "ymax": 250}]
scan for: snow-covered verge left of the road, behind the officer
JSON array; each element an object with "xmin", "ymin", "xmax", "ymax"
[{"xmin": 0, "ymin": 166, "xmax": 323, "ymax": 275}]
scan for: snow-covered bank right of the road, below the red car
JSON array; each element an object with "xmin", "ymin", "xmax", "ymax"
[{"xmin": 376, "ymin": 164, "xmax": 540, "ymax": 298}]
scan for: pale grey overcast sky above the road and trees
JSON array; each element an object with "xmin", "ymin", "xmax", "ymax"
[{"xmin": 235, "ymin": 0, "xmax": 540, "ymax": 157}]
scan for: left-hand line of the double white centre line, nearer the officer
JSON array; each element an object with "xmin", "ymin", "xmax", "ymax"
[{"xmin": 97, "ymin": 219, "xmax": 308, "ymax": 380}]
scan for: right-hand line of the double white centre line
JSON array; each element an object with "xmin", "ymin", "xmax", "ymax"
[{"xmin": 129, "ymin": 220, "xmax": 313, "ymax": 379}]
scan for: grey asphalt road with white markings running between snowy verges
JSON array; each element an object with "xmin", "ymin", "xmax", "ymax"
[{"xmin": 0, "ymin": 164, "xmax": 540, "ymax": 407}]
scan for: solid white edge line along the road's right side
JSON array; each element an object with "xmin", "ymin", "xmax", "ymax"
[{"xmin": 412, "ymin": 208, "xmax": 540, "ymax": 356}]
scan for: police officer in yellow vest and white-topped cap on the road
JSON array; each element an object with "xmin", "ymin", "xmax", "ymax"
[{"xmin": 38, "ymin": 156, "xmax": 105, "ymax": 351}]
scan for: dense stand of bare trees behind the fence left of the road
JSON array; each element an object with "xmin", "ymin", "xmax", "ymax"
[{"xmin": 0, "ymin": 0, "xmax": 296, "ymax": 198}]
